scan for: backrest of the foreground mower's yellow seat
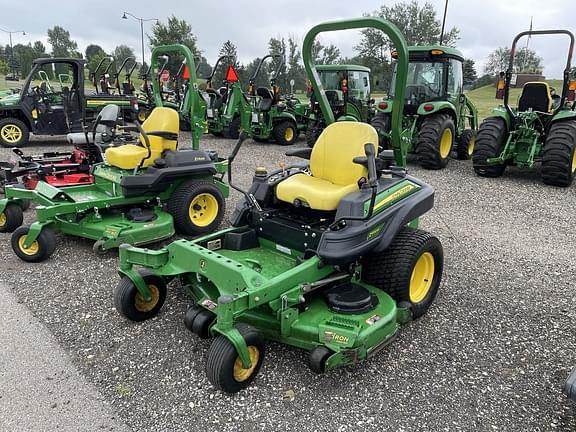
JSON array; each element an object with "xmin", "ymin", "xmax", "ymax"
[{"xmin": 310, "ymin": 122, "xmax": 378, "ymax": 186}]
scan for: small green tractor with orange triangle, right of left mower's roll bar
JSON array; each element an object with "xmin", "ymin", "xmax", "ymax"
[{"xmin": 206, "ymin": 55, "xmax": 248, "ymax": 139}]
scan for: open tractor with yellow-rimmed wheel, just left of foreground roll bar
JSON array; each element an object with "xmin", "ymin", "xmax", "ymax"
[{"xmin": 248, "ymin": 54, "xmax": 306, "ymax": 145}]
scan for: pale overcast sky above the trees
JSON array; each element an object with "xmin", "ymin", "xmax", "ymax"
[{"xmin": 0, "ymin": 0, "xmax": 576, "ymax": 78}]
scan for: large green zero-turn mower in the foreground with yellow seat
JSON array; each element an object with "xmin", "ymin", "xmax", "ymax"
[{"xmin": 114, "ymin": 17, "xmax": 443, "ymax": 393}]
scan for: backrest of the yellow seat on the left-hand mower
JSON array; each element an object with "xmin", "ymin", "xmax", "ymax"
[{"xmin": 139, "ymin": 107, "xmax": 180, "ymax": 154}]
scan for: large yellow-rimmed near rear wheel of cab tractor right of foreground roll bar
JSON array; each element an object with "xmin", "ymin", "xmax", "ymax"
[{"xmin": 416, "ymin": 114, "xmax": 455, "ymax": 170}]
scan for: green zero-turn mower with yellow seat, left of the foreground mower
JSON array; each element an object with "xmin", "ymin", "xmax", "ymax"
[{"xmin": 0, "ymin": 45, "xmax": 228, "ymax": 262}]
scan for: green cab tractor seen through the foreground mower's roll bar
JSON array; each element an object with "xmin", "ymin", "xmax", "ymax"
[{"xmin": 306, "ymin": 64, "xmax": 374, "ymax": 147}]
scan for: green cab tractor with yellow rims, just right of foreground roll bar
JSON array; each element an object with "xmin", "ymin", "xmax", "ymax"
[{"xmin": 371, "ymin": 45, "xmax": 478, "ymax": 169}]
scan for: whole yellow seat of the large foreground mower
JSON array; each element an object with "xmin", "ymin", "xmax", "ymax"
[{"xmin": 276, "ymin": 122, "xmax": 378, "ymax": 211}]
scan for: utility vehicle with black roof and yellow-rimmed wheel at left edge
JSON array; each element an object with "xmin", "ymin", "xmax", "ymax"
[{"xmin": 0, "ymin": 58, "xmax": 138, "ymax": 147}]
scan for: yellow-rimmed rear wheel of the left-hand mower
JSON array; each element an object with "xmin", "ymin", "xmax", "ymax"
[{"xmin": 167, "ymin": 180, "xmax": 226, "ymax": 236}]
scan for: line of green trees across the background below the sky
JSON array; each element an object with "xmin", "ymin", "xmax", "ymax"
[{"xmin": 0, "ymin": 0, "xmax": 542, "ymax": 91}]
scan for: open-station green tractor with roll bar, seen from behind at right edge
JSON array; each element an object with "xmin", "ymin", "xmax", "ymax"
[{"xmin": 472, "ymin": 30, "xmax": 576, "ymax": 186}]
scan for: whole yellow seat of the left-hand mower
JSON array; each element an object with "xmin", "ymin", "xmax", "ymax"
[{"xmin": 104, "ymin": 107, "xmax": 180, "ymax": 169}]
